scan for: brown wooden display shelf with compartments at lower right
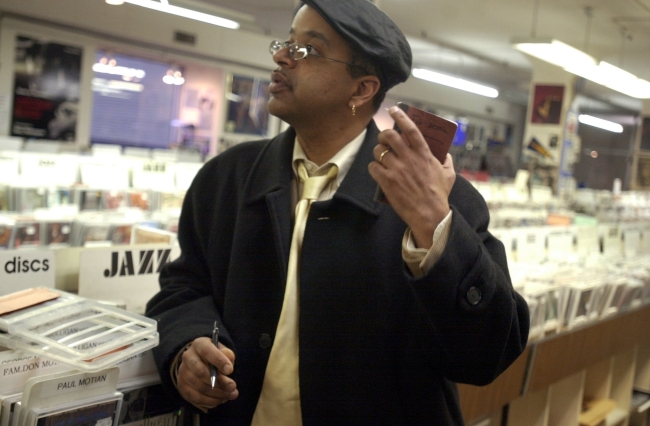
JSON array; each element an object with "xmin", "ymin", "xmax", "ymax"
[{"xmin": 459, "ymin": 305, "xmax": 650, "ymax": 426}]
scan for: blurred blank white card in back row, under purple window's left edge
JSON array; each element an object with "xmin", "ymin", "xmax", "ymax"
[{"xmin": 79, "ymin": 156, "xmax": 129, "ymax": 189}]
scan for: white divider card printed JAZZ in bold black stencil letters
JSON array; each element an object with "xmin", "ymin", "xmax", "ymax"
[{"xmin": 79, "ymin": 244, "xmax": 180, "ymax": 314}]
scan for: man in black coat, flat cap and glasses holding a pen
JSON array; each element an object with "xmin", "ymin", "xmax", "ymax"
[{"xmin": 148, "ymin": 0, "xmax": 528, "ymax": 426}]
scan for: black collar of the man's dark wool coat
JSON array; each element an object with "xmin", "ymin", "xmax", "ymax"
[{"xmin": 246, "ymin": 120, "xmax": 381, "ymax": 214}]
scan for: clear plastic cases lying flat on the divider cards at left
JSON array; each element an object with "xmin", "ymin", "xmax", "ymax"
[{"xmin": 0, "ymin": 287, "xmax": 158, "ymax": 371}]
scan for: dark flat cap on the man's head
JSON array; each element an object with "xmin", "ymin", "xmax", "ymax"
[{"xmin": 303, "ymin": 0, "xmax": 413, "ymax": 90}]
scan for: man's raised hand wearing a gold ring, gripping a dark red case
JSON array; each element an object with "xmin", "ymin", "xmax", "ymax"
[{"xmin": 368, "ymin": 107, "xmax": 456, "ymax": 249}]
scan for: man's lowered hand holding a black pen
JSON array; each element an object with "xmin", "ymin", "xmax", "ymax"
[{"xmin": 176, "ymin": 337, "xmax": 239, "ymax": 412}]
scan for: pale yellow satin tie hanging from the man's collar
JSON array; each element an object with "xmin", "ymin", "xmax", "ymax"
[{"xmin": 251, "ymin": 161, "xmax": 338, "ymax": 426}]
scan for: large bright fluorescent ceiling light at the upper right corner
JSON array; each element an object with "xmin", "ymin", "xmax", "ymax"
[{"xmin": 512, "ymin": 38, "xmax": 650, "ymax": 99}]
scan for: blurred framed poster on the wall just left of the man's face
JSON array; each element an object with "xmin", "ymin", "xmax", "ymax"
[{"xmin": 224, "ymin": 75, "xmax": 271, "ymax": 136}]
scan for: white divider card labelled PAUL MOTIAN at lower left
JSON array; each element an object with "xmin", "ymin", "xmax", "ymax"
[{"xmin": 22, "ymin": 367, "xmax": 120, "ymax": 410}]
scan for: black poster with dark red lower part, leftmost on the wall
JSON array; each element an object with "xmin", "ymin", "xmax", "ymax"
[{"xmin": 11, "ymin": 35, "xmax": 82, "ymax": 141}]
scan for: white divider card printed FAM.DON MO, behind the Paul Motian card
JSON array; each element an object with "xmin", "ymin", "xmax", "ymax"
[{"xmin": 0, "ymin": 350, "xmax": 72, "ymax": 395}]
